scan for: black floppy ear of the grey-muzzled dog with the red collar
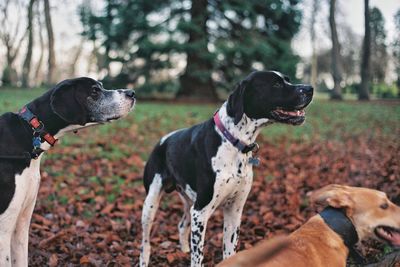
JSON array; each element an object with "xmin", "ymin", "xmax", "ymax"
[{"xmin": 50, "ymin": 81, "xmax": 87, "ymax": 125}]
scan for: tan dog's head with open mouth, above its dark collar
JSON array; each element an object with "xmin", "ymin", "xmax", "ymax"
[{"xmin": 309, "ymin": 185, "xmax": 400, "ymax": 246}]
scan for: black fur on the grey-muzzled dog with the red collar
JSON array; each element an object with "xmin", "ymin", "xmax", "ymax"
[{"xmin": 0, "ymin": 77, "xmax": 134, "ymax": 214}]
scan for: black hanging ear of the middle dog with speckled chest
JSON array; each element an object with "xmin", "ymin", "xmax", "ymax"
[{"xmin": 226, "ymin": 79, "xmax": 248, "ymax": 125}]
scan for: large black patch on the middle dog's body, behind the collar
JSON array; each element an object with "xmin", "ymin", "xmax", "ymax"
[{"xmin": 144, "ymin": 120, "xmax": 222, "ymax": 210}]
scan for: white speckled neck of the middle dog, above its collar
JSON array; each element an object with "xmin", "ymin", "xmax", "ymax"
[{"xmin": 217, "ymin": 102, "xmax": 269, "ymax": 144}]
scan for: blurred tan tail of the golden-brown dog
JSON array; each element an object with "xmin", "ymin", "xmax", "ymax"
[{"xmin": 217, "ymin": 236, "xmax": 291, "ymax": 267}]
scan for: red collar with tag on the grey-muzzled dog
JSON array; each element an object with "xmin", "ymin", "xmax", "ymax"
[{"xmin": 18, "ymin": 106, "xmax": 57, "ymax": 148}]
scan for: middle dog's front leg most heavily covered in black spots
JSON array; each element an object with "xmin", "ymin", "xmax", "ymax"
[{"xmin": 190, "ymin": 206, "xmax": 212, "ymax": 267}]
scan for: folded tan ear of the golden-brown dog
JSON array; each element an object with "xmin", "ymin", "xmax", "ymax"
[{"xmin": 307, "ymin": 184, "xmax": 354, "ymax": 215}]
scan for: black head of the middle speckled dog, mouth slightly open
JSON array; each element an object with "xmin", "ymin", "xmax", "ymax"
[{"xmin": 227, "ymin": 71, "xmax": 313, "ymax": 125}]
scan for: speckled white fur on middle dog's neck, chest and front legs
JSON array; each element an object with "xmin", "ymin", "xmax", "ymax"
[{"xmin": 191, "ymin": 103, "xmax": 268, "ymax": 266}]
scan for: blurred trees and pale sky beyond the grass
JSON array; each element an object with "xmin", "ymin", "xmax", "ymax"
[{"xmin": 0, "ymin": 0, "xmax": 400, "ymax": 101}]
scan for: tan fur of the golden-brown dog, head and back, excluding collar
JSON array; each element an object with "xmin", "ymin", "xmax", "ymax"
[{"xmin": 218, "ymin": 185, "xmax": 400, "ymax": 267}]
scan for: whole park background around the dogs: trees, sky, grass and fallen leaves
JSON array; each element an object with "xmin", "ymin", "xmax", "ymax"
[{"xmin": 0, "ymin": 0, "xmax": 400, "ymax": 267}]
